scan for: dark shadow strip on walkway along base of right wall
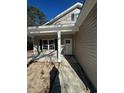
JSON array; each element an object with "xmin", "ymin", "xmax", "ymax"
[{"xmin": 64, "ymin": 55, "xmax": 97, "ymax": 93}]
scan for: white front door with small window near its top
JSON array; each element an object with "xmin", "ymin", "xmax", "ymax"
[{"xmin": 64, "ymin": 39, "xmax": 72, "ymax": 55}]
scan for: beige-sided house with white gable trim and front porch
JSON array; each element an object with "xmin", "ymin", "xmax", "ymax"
[{"xmin": 28, "ymin": 0, "xmax": 97, "ymax": 91}]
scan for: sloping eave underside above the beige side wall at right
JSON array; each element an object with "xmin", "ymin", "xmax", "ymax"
[{"xmin": 75, "ymin": 0, "xmax": 97, "ymax": 27}]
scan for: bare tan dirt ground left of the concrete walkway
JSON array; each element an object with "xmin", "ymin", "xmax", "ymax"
[{"xmin": 27, "ymin": 62, "xmax": 59, "ymax": 93}]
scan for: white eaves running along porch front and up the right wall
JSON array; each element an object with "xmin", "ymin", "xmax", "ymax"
[{"xmin": 27, "ymin": 0, "xmax": 97, "ymax": 36}]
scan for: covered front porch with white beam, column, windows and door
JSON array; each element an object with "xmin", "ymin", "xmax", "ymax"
[{"xmin": 28, "ymin": 24, "xmax": 78, "ymax": 62}]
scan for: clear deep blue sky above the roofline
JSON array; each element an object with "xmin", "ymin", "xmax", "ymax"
[{"xmin": 27, "ymin": 0, "xmax": 84, "ymax": 21}]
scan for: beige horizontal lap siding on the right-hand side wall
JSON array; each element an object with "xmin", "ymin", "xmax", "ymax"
[{"xmin": 73, "ymin": 5, "xmax": 97, "ymax": 87}]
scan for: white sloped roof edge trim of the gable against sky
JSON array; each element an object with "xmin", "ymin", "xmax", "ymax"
[{"xmin": 44, "ymin": 2, "xmax": 83, "ymax": 25}]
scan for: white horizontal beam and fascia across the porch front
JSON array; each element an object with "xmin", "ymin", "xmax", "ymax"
[{"xmin": 27, "ymin": 24, "xmax": 78, "ymax": 35}]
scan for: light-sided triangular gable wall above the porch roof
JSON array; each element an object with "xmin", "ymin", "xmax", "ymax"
[{"xmin": 53, "ymin": 9, "xmax": 80, "ymax": 24}]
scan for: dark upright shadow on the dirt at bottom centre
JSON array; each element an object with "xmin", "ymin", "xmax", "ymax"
[{"xmin": 49, "ymin": 66, "xmax": 61, "ymax": 93}]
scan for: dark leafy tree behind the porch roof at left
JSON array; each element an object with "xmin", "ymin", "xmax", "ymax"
[{"xmin": 27, "ymin": 6, "xmax": 47, "ymax": 26}]
